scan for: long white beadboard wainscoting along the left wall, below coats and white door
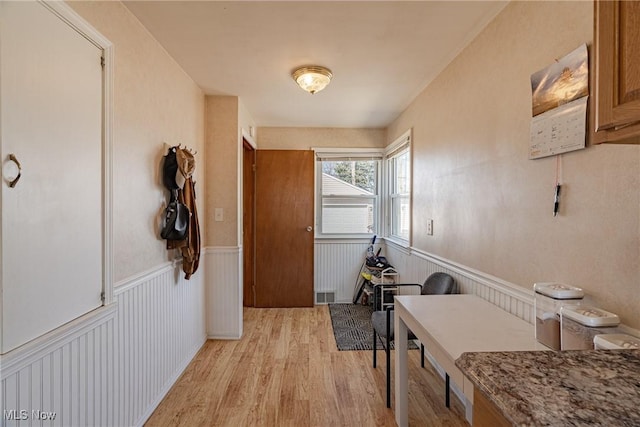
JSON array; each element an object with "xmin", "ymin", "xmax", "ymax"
[{"xmin": 0, "ymin": 263, "xmax": 206, "ymax": 427}]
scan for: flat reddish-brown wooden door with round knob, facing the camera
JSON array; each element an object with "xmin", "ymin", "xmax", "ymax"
[{"xmin": 256, "ymin": 150, "xmax": 314, "ymax": 307}]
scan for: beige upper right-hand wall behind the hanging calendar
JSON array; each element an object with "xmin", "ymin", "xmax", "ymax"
[{"xmin": 387, "ymin": 2, "xmax": 640, "ymax": 328}]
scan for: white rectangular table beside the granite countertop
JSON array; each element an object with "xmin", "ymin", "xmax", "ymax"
[{"xmin": 394, "ymin": 295, "xmax": 548, "ymax": 427}]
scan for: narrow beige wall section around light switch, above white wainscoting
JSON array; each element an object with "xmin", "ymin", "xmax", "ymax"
[{"xmin": 203, "ymin": 96, "xmax": 240, "ymax": 246}]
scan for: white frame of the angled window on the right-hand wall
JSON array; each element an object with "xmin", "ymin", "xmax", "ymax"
[{"xmin": 384, "ymin": 129, "xmax": 413, "ymax": 248}]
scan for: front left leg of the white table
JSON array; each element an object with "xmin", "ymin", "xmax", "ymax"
[{"xmin": 394, "ymin": 309, "xmax": 409, "ymax": 427}]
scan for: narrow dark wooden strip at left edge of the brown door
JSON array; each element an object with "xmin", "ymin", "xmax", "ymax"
[{"xmin": 242, "ymin": 140, "xmax": 256, "ymax": 307}]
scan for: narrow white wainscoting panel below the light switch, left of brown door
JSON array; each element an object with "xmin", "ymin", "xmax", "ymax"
[{"xmin": 204, "ymin": 247, "xmax": 243, "ymax": 339}]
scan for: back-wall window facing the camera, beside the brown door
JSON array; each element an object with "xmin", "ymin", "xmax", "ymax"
[{"xmin": 316, "ymin": 153, "xmax": 381, "ymax": 237}]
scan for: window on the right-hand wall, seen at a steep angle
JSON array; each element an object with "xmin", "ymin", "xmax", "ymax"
[{"xmin": 386, "ymin": 131, "xmax": 411, "ymax": 244}]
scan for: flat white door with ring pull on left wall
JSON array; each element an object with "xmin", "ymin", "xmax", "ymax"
[{"xmin": 0, "ymin": 1, "xmax": 103, "ymax": 354}]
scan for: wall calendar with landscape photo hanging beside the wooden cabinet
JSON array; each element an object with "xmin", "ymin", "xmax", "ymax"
[{"xmin": 529, "ymin": 45, "xmax": 589, "ymax": 159}]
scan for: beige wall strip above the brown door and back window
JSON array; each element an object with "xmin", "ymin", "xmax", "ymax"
[{"xmin": 258, "ymin": 127, "xmax": 386, "ymax": 150}]
